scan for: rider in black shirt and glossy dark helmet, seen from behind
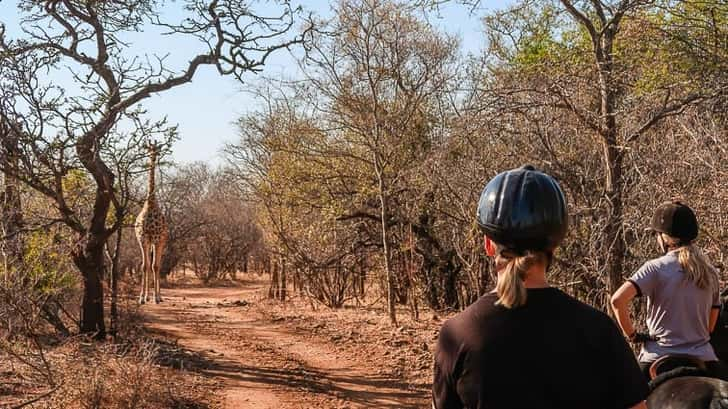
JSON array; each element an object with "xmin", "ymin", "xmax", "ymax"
[{"xmin": 432, "ymin": 166, "xmax": 648, "ymax": 409}]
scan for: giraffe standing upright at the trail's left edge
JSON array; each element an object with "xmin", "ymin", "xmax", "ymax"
[{"xmin": 134, "ymin": 144, "xmax": 168, "ymax": 304}]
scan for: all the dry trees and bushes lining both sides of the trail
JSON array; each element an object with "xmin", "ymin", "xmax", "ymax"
[{"xmin": 0, "ymin": 0, "xmax": 728, "ymax": 407}]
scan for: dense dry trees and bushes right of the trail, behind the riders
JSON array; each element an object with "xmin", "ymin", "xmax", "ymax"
[{"xmin": 226, "ymin": 1, "xmax": 728, "ymax": 321}]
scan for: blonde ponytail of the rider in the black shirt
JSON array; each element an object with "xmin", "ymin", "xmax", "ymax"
[{"xmin": 495, "ymin": 251, "xmax": 546, "ymax": 309}]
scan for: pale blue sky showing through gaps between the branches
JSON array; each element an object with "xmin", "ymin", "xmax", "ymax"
[{"xmin": 0, "ymin": 0, "xmax": 512, "ymax": 163}]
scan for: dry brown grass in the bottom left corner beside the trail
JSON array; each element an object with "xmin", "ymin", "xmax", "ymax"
[{"xmin": 0, "ymin": 338, "xmax": 215, "ymax": 409}]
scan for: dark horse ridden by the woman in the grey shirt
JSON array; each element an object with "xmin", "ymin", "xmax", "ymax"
[{"xmin": 647, "ymin": 289, "xmax": 728, "ymax": 409}]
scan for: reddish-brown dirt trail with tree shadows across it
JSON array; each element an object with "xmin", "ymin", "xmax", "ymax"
[{"xmin": 143, "ymin": 281, "xmax": 427, "ymax": 408}]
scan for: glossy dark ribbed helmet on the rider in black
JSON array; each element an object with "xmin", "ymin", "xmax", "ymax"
[{"xmin": 477, "ymin": 165, "xmax": 568, "ymax": 253}]
